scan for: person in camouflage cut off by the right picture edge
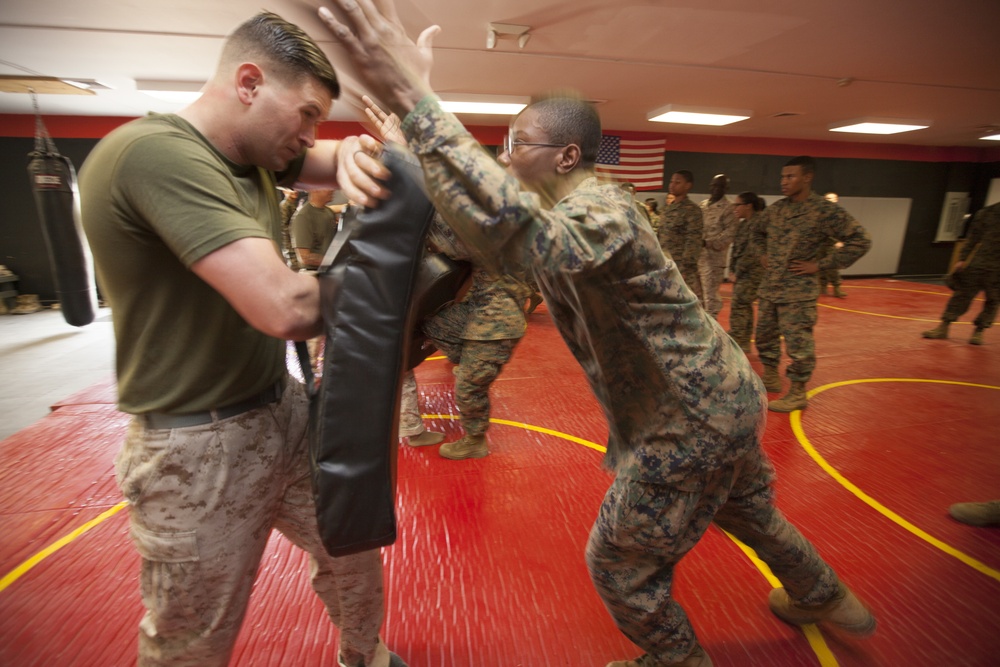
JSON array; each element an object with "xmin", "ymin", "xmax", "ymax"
[{"xmin": 923, "ymin": 203, "xmax": 1000, "ymax": 345}]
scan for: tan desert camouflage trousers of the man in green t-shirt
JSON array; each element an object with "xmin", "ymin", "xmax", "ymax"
[{"xmin": 115, "ymin": 378, "xmax": 389, "ymax": 667}]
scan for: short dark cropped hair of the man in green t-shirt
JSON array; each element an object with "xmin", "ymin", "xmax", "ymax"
[{"xmin": 222, "ymin": 12, "xmax": 340, "ymax": 99}]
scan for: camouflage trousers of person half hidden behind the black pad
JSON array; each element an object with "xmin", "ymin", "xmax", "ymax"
[{"xmin": 424, "ymin": 317, "xmax": 521, "ymax": 436}]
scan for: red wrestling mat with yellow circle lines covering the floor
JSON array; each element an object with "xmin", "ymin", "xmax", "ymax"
[{"xmin": 0, "ymin": 280, "xmax": 1000, "ymax": 667}]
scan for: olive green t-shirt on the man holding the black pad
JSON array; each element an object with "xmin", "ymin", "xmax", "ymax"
[{"xmin": 80, "ymin": 114, "xmax": 302, "ymax": 414}]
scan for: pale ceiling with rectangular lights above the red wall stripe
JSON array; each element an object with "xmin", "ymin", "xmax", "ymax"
[{"xmin": 0, "ymin": 0, "xmax": 1000, "ymax": 147}]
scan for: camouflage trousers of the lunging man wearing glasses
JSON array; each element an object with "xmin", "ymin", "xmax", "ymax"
[{"xmin": 587, "ymin": 447, "xmax": 838, "ymax": 665}]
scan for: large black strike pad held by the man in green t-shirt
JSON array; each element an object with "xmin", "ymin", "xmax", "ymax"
[{"xmin": 308, "ymin": 149, "xmax": 434, "ymax": 556}]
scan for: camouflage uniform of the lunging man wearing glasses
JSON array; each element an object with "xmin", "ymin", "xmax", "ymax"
[{"xmin": 402, "ymin": 97, "xmax": 838, "ymax": 664}]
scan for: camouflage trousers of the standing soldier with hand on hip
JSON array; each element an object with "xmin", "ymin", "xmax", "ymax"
[{"xmin": 756, "ymin": 299, "xmax": 816, "ymax": 382}]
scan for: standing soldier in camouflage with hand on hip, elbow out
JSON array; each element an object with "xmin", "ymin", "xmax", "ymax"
[{"xmin": 753, "ymin": 155, "xmax": 871, "ymax": 412}]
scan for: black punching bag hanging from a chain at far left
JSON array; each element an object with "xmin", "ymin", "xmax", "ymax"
[{"xmin": 28, "ymin": 119, "xmax": 97, "ymax": 327}]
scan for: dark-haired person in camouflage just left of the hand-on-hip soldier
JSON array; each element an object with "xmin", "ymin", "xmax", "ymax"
[{"xmin": 729, "ymin": 192, "xmax": 766, "ymax": 353}]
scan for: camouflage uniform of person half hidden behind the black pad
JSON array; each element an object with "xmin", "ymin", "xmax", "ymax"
[{"xmin": 423, "ymin": 216, "xmax": 532, "ymax": 436}]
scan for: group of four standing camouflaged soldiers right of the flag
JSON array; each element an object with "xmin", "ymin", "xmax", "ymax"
[{"xmin": 654, "ymin": 161, "xmax": 871, "ymax": 412}]
